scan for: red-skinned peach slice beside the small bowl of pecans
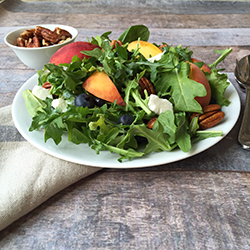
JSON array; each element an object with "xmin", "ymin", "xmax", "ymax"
[{"xmin": 49, "ymin": 42, "xmax": 101, "ymax": 65}]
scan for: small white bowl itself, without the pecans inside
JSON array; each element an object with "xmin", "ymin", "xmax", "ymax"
[{"xmin": 4, "ymin": 24, "xmax": 78, "ymax": 70}]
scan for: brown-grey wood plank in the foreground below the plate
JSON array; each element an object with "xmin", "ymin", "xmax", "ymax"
[{"xmin": 0, "ymin": 171, "xmax": 250, "ymax": 250}]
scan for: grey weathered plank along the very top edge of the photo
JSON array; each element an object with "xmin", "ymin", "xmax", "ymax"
[{"xmin": 1, "ymin": 0, "xmax": 250, "ymax": 15}]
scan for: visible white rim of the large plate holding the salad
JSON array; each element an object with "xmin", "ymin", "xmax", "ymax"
[{"xmin": 12, "ymin": 75, "xmax": 240, "ymax": 168}]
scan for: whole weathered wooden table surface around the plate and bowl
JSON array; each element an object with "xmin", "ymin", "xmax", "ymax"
[{"xmin": 0, "ymin": 0, "xmax": 250, "ymax": 250}]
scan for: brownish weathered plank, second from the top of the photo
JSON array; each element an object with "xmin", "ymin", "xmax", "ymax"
[{"xmin": 0, "ymin": 6, "xmax": 250, "ymax": 30}]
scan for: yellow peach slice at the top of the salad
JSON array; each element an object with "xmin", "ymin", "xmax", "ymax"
[{"xmin": 128, "ymin": 41, "xmax": 162, "ymax": 59}]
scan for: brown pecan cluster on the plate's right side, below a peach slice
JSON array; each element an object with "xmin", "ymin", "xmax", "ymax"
[{"xmin": 190, "ymin": 104, "xmax": 225, "ymax": 130}]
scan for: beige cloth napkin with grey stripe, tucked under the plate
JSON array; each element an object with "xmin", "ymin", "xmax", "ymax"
[{"xmin": 0, "ymin": 106, "xmax": 101, "ymax": 230}]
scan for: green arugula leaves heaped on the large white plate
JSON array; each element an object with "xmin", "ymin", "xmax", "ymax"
[{"xmin": 23, "ymin": 25, "xmax": 231, "ymax": 162}]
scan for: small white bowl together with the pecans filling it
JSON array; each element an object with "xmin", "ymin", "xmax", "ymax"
[{"xmin": 4, "ymin": 24, "xmax": 78, "ymax": 70}]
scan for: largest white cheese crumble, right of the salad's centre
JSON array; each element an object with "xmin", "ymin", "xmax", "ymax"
[{"xmin": 148, "ymin": 94, "xmax": 173, "ymax": 115}]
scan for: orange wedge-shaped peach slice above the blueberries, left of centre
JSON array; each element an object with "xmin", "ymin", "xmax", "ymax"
[{"xmin": 83, "ymin": 71, "xmax": 126, "ymax": 106}]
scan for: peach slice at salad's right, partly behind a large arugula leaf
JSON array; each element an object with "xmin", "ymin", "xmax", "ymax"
[{"xmin": 189, "ymin": 63, "xmax": 211, "ymax": 107}]
